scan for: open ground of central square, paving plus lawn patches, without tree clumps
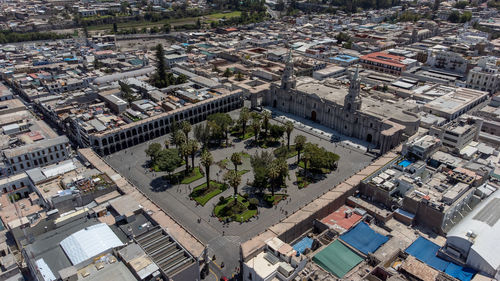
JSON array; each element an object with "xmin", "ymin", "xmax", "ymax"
[{"xmin": 105, "ymin": 106, "xmax": 374, "ymax": 274}]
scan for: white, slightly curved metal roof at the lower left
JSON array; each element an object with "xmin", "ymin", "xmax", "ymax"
[{"xmin": 60, "ymin": 223, "xmax": 124, "ymax": 265}]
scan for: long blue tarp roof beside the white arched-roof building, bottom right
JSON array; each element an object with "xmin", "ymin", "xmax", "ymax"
[{"xmin": 406, "ymin": 237, "xmax": 476, "ymax": 281}]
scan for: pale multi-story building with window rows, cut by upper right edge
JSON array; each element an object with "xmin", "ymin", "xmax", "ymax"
[{"xmin": 466, "ymin": 57, "xmax": 500, "ymax": 94}]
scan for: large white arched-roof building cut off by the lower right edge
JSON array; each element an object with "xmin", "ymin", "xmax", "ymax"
[{"xmin": 446, "ymin": 187, "xmax": 500, "ymax": 280}]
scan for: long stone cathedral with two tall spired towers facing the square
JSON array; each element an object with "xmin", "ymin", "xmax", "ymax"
[{"xmin": 262, "ymin": 52, "xmax": 420, "ymax": 153}]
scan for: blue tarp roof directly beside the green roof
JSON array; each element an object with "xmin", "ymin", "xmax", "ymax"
[{"xmin": 340, "ymin": 222, "xmax": 389, "ymax": 255}]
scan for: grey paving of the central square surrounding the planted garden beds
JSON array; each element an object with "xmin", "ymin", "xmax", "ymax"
[{"xmin": 104, "ymin": 106, "xmax": 374, "ymax": 274}]
